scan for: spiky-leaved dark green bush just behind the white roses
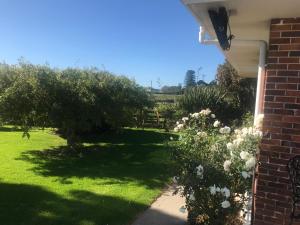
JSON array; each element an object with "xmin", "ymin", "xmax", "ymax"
[{"xmin": 179, "ymin": 86, "xmax": 242, "ymax": 123}]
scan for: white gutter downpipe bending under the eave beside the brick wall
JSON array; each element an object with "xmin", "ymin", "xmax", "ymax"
[{"xmin": 199, "ymin": 26, "xmax": 267, "ymax": 118}]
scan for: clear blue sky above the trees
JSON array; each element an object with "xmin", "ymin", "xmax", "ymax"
[{"xmin": 0, "ymin": 0, "xmax": 224, "ymax": 87}]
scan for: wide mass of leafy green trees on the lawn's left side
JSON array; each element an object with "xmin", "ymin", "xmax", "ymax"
[{"xmin": 0, "ymin": 63, "xmax": 152, "ymax": 145}]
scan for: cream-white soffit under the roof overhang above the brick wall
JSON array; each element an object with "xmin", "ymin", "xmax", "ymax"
[{"xmin": 182, "ymin": 0, "xmax": 300, "ymax": 77}]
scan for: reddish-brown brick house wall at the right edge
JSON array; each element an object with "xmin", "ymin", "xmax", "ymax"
[{"xmin": 254, "ymin": 18, "xmax": 300, "ymax": 225}]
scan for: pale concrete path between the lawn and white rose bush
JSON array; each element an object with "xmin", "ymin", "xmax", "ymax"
[{"xmin": 132, "ymin": 186, "xmax": 187, "ymax": 225}]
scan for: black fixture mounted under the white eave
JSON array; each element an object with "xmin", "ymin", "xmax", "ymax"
[{"xmin": 208, "ymin": 7, "xmax": 234, "ymax": 51}]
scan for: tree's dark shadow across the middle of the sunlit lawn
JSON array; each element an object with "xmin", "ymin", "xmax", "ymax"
[{"xmin": 18, "ymin": 128, "xmax": 172, "ymax": 188}]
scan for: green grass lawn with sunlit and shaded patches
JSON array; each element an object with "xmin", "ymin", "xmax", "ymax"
[{"xmin": 0, "ymin": 127, "xmax": 175, "ymax": 225}]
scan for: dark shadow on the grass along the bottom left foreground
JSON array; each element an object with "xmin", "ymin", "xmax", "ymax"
[{"xmin": 0, "ymin": 183, "xmax": 147, "ymax": 225}]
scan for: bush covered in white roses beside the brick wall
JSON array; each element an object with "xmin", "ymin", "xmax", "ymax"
[{"xmin": 173, "ymin": 109, "xmax": 262, "ymax": 225}]
